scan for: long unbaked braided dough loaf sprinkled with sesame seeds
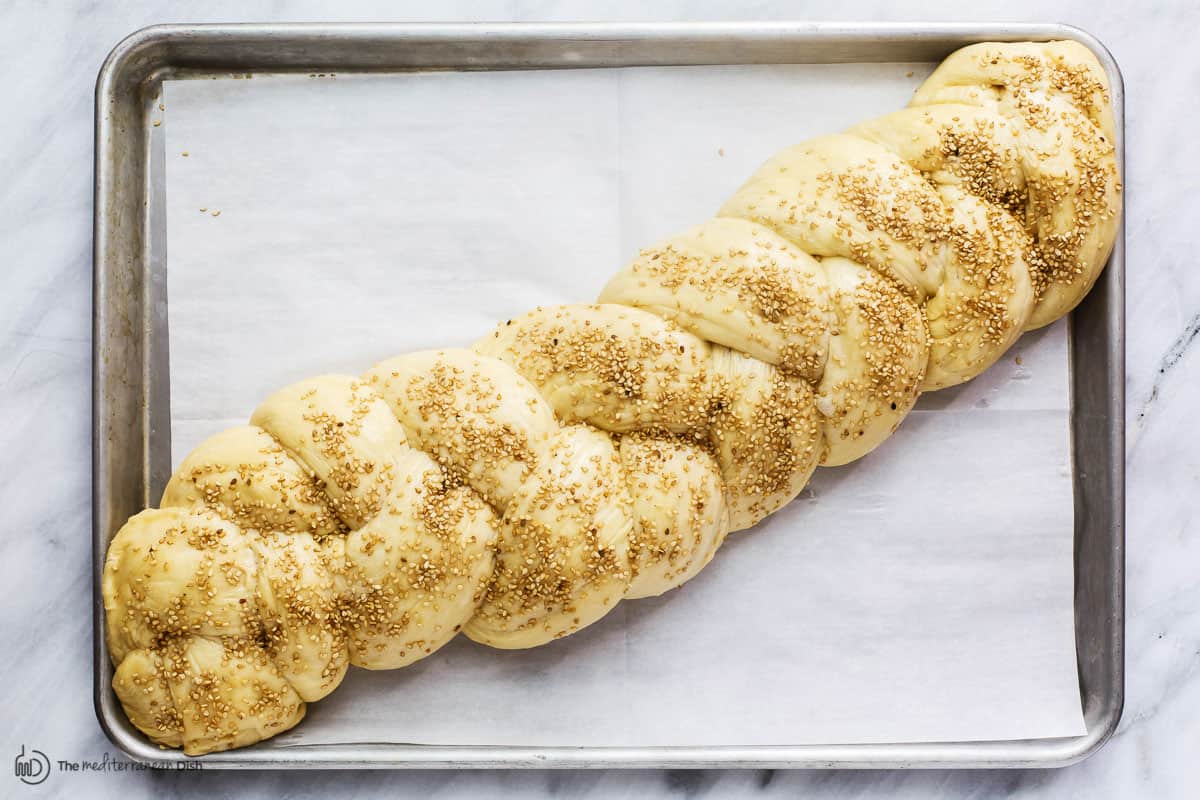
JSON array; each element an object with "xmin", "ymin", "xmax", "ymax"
[{"xmin": 103, "ymin": 42, "xmax": 1121, "ymax": 754}]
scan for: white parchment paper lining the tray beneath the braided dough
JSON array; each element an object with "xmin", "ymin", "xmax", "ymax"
[{"xmin": 161, "ymin": 65, "xmax": 1085, "ymax": 746}]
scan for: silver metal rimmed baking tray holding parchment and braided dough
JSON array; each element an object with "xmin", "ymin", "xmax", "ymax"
[{"xmin": 92, "ymin": 22, "xmax": 1124, "ymax": 768}]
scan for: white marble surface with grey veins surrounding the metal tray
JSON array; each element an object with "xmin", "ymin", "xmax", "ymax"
[{"xmin": 0, "ymin": 0, "xmax": 1200, "ymax": 798}]
